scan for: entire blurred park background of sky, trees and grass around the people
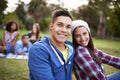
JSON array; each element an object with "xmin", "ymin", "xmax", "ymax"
[{"xmin": 0, "ymin": 0, "xmax": 120, "ymax": 80}]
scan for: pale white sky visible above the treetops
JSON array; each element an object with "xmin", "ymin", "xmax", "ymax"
[{"xmin": 3, "ymin": 0, "xmax": 88, "ymax": 14}]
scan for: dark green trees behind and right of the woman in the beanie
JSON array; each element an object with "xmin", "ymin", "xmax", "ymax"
[{"xmin": 71, "ymin": 0, "xmax": 120, "ymax": 38}]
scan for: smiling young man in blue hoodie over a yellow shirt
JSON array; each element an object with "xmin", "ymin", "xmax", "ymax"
[{"xmin": 28, "ymin": 9, "xmax": 74, "ymax": 80}]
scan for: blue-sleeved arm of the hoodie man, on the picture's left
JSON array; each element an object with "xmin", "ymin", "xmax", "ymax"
[{"xmin": 28, "ymin": 45, "xmax": 54, "ymax": 80}]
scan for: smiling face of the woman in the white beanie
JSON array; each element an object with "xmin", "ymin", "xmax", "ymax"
[{"xmin": 74, "ymin": 27, "xmax": 90, "ymax": 46}]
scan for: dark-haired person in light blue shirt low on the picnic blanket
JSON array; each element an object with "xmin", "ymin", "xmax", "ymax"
[{"xmin": 15, "ymin": 34, "xmax": 32, "ymax": 55}]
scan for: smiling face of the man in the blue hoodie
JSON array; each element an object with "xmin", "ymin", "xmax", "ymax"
[{"xmin": 50, "ymin": 16, "xmax": 72, "ymax": 44}]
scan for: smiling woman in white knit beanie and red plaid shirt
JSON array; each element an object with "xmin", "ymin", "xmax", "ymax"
[{"xmin": 72, "ymin": 20, "xmax": 120, "ymax": 80}]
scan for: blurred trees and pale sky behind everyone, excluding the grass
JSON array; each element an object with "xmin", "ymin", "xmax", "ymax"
[{"xmin": 0, "ymin": 0, "xmax": 120, "ymax": 40}]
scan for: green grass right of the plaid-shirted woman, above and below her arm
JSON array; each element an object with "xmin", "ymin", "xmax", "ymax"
[{"xmin": 93, "ymin": 38, "xmax": 120, "ymax": 75}]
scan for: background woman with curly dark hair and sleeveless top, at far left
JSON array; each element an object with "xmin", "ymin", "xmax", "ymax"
[{"xmin": 3, "ymin": 21, "xmax": 19, "ymax": 53}]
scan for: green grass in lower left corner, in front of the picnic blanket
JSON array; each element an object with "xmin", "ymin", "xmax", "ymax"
[{"xmin": 0, "ymin": 58, "xmax": 29, "ymax": 80}]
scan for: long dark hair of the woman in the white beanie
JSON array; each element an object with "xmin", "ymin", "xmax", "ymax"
[{"xmin": 72, "ymin": 26, "xmax": 102, "ymax": 64}]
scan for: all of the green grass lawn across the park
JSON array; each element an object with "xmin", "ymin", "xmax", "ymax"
[{"xmin": 0, "ymin": 29, "xmax": 120, "ymax": 80}]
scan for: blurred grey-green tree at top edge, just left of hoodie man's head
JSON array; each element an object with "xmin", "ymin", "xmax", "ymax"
[{"xmin": 28, "ymin": 0, "xmax": 51, "ymax": 30}]
